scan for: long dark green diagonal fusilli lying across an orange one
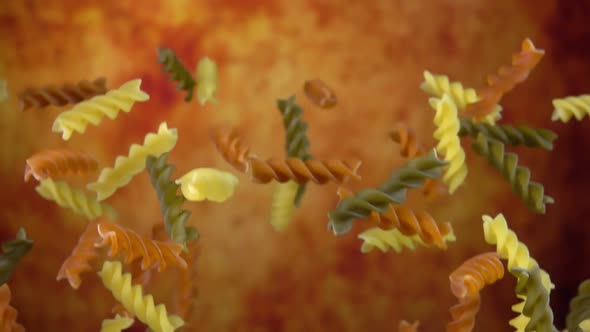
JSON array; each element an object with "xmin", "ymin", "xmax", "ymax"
[{"xmin": 328, "ymin": 150, "xmax": 447, "ymax": 235}]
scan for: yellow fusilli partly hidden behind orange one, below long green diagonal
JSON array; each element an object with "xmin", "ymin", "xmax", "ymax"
[{"xmin": 358, "ymin": 227, "xmax": 455, "ymax": 253}]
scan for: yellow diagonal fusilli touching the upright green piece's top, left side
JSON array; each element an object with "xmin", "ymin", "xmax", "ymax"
[{"xmin": 88, "ymin": 122, "xmax": 178, "ymax": 201}]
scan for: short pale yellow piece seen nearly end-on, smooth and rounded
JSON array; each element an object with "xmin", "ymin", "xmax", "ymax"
[{"xmin": 175, "ymin": 168, "xmax": 239, "ymax": 203}]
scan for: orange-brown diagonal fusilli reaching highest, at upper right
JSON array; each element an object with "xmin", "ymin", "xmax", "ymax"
[{"xmin": 467, "ymin": 38, "xmax": 545, "ymax": 119}]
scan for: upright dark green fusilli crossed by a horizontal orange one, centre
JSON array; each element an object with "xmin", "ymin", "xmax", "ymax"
[{"xmin": 277, "ymin": 96, "xmax": 313, "ymax": 206}]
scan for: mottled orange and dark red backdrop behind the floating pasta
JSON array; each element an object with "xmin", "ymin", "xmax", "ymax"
[{"xmin": 0, "ymin": 0, "xmax": 590, "ymax": 332}]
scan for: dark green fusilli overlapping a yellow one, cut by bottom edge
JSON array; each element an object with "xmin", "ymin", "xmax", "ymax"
[{"xmin": 510, "ymin": 266, "xmax": 557, "ymax": 332}]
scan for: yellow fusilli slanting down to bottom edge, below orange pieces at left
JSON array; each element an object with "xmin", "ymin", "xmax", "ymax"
[{"xmin": 98, "ymin": 261, "xmax": 184, "ymax": 332}]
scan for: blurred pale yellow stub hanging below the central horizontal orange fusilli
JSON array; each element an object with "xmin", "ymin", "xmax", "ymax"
[{"xmin": 270, "ymin": 181, "xmax": 299, "ymax": 232}]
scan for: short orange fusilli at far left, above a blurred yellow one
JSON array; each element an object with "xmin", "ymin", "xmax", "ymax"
[{"xmin": 24, "ymin": 149, "xmax": 98, "ymax": 182}]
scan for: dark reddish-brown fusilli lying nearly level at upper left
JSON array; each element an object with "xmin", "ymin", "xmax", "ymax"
[{"xmin": 18, "ymin": 78, "xmax": 107, "ymax": 112}]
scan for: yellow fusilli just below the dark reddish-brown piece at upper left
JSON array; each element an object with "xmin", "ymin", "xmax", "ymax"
[{"xmin": 51, "ymin": 79, "xmax": 150, "ymax": 141}]
